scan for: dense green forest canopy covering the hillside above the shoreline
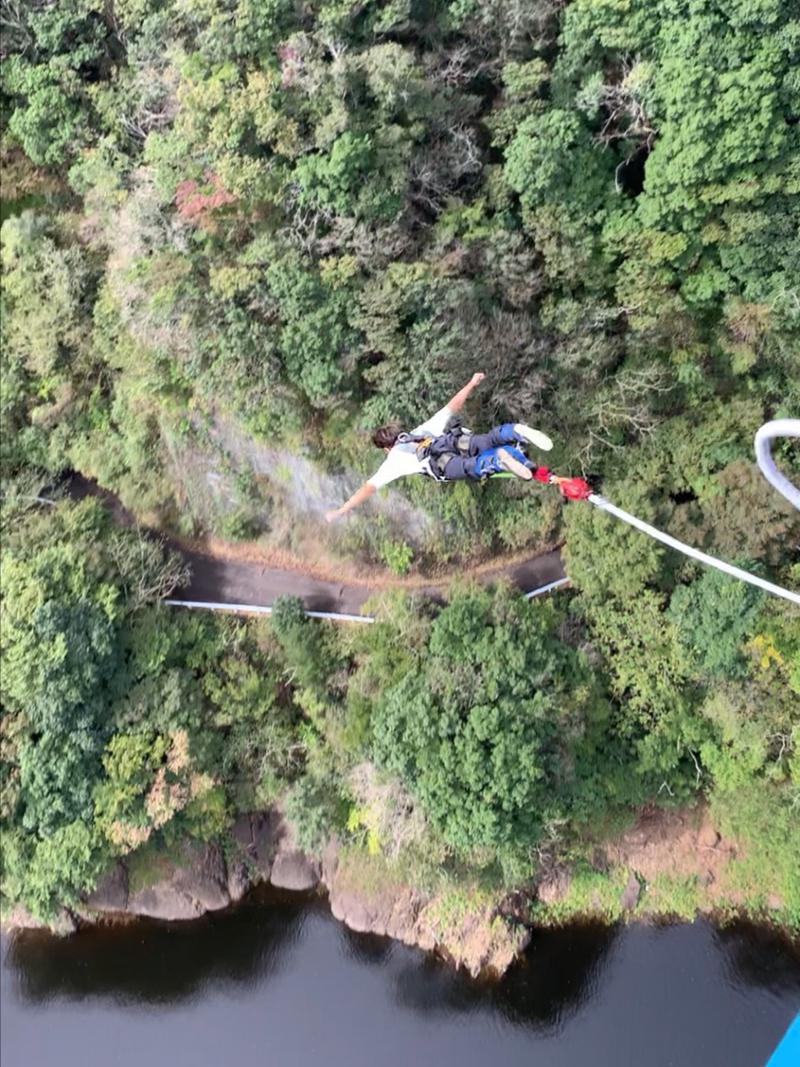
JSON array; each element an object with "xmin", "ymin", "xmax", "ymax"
[{"xmin": 0, "ymin": 0, "xmax": 800, "ymax": 923}]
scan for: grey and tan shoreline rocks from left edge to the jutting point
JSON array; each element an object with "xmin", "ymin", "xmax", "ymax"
[{"xmin": 3, "ymin": 811, "xmax": 530, "ymax": 975}]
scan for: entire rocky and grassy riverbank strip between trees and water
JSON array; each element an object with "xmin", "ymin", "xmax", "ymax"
[{"xmin": 3, "ymin": 808, "xmax": 791, "ymax": 977}]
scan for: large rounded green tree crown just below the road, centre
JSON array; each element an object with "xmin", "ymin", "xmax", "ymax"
[{"xmin": 372, "ymin": 592, "xmax": 596, "ymax": 853}]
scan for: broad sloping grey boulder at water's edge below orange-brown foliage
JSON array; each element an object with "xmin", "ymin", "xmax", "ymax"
[{"xmin": 128, "ymin": 844, "xmax": 230, "ymax": 920}]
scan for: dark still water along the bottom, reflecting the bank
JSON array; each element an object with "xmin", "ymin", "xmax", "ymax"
[{"xmin": 0, "ymin": 894, "xmax": 800, "ymax": 1067}]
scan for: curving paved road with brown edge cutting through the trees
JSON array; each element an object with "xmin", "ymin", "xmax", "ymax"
[{"xmin": 66, "ymin": 474, "xmax": 565, "ymax": 615}]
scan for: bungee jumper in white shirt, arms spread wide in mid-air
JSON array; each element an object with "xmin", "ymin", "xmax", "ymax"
[{"xmin": 325, "ymin": 373, "xmax": 566, "ymax": 523}]
